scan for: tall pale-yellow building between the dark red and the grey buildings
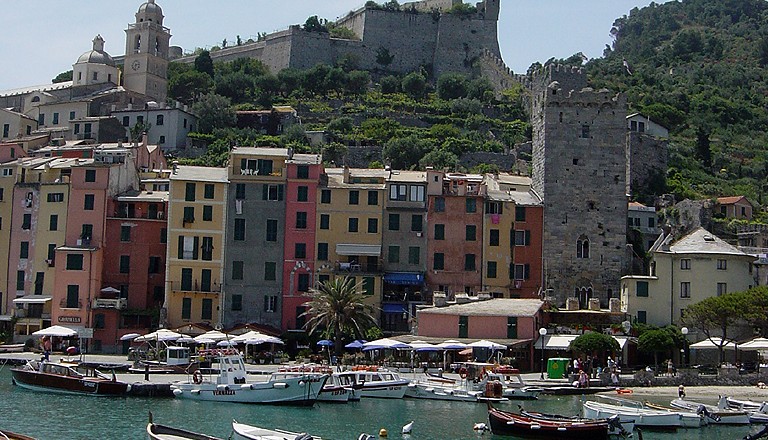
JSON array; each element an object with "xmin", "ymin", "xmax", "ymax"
[{"xmin": 166, "ymin": 166, "xmax": 228, "ymax": 328}]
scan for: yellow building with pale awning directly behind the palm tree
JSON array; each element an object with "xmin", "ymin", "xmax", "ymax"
[{"xmin": 315, "ymin": 168, "xmax": 389, "ymax": 314}]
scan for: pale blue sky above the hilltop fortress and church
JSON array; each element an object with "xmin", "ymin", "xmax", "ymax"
[{"xmin": 0, "ymin": 0, "xmax": 664, "ymax": 90}]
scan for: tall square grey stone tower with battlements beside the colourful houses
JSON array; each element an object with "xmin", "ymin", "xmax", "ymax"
[{"xmin": 528, "ymin": 65, "xmax": 627, "ymax": 308}]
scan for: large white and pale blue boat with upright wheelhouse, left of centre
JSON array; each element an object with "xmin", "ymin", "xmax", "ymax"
[{"xmin": 171, "ymin": 349, "xmax": 328, "ymax": 406}]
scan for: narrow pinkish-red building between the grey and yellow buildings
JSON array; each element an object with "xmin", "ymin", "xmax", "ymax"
[{"xmin": 282, "ymin": 154, "xmax": 323, "ymax": 330}]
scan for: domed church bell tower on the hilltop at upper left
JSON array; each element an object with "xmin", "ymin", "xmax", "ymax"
[{"xmin": 123, "ymin": 0, "xmax": 171, "ymax": 102}]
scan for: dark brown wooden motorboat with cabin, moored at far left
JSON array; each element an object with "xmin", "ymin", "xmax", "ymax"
[{"xmin": 11, "ymin": 361, "xmax": 129, "ymax": 396}]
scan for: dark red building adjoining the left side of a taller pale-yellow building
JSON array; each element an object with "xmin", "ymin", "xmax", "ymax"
[{"xmin": 98, "ymin": 191, "xmax": 168, "ymax": 352}]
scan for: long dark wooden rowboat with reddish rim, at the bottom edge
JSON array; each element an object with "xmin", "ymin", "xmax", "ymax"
[{"xmin": 488, "ymin": 407, "xmax": 608, "ymax": 440}]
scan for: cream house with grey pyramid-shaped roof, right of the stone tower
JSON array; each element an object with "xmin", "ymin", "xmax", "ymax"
[{"xmin": 621, "ymin": 228, "xmax": 756, "ymax": 326}]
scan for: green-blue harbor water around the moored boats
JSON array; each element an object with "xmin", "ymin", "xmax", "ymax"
[{"xmin": 0, "ymin": 367, "xmax": 761, "ymax": 440}]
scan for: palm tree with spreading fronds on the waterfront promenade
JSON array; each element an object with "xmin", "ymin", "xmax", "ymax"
[{"xmin": 301, "ymin": 277, "xmax": 376, "ymax": 354}]
